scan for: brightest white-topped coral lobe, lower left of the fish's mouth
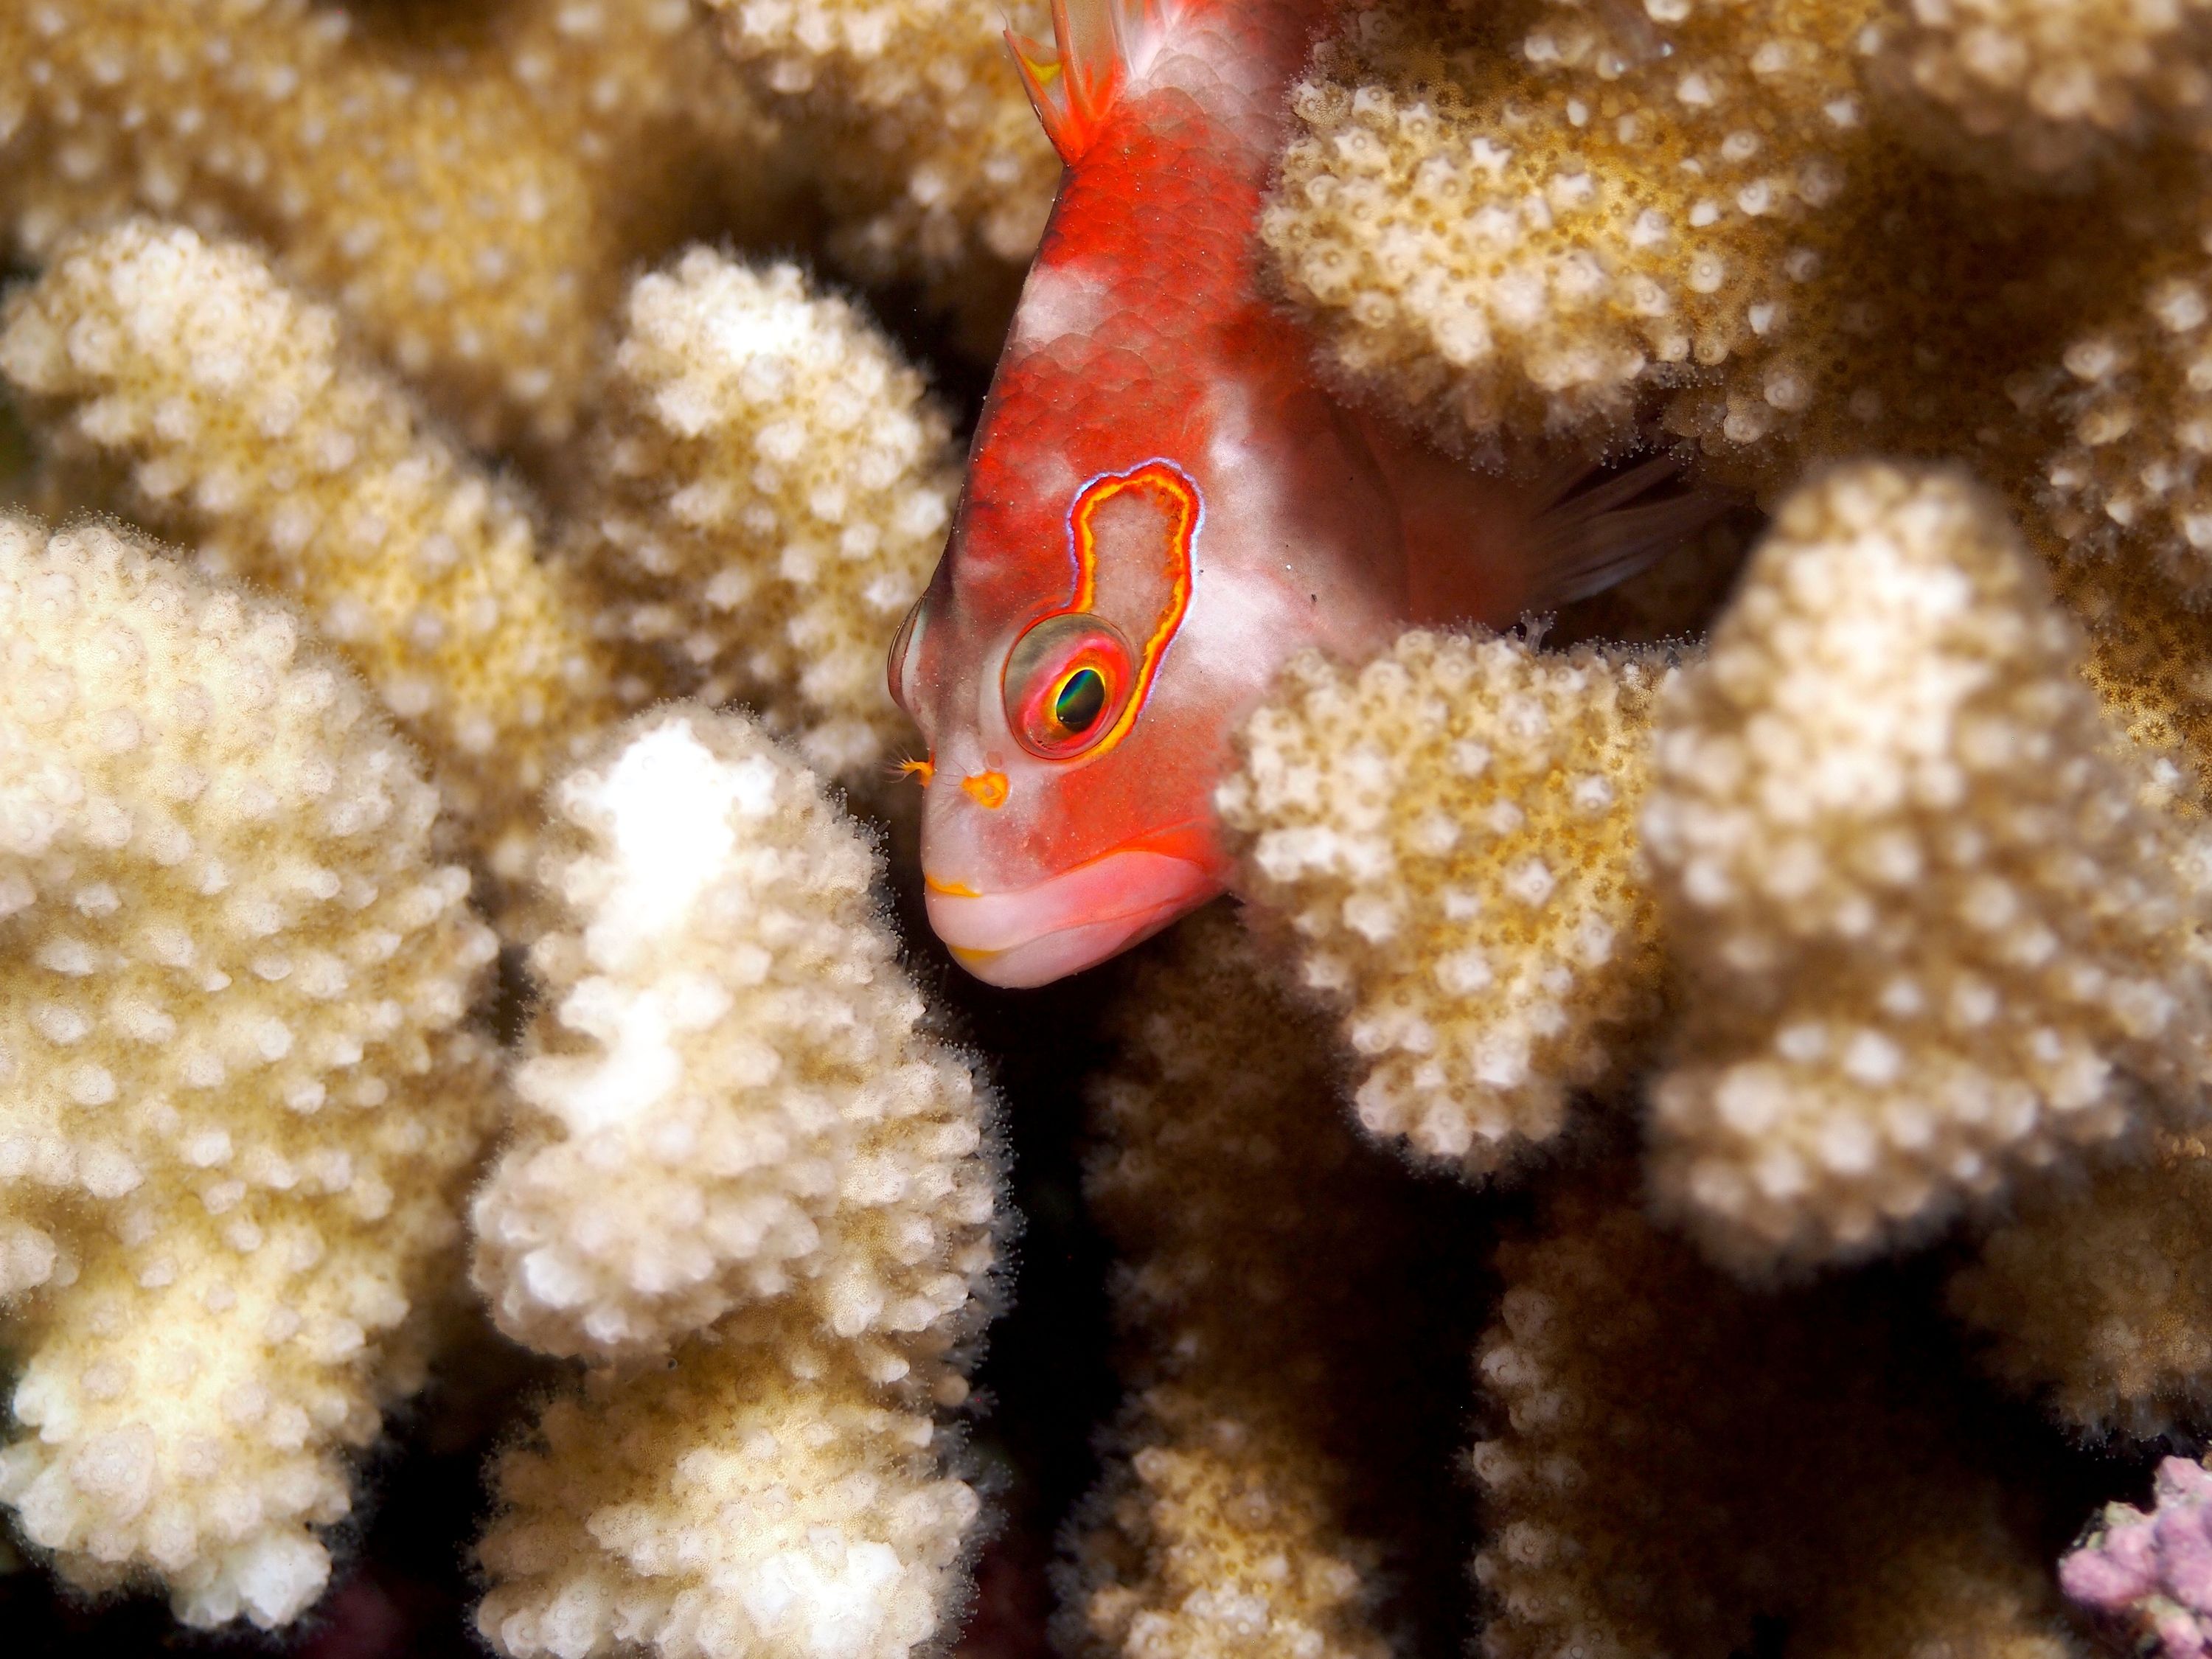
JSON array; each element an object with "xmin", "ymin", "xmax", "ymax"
[{"xmin": 476, "ymin": 706, "xmax": 995, "ymax": 1382}]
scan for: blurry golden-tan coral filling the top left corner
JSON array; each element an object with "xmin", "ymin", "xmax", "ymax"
[{"xmin": 0, "ymin": 0, "xmax": 776, "ymax": 442}]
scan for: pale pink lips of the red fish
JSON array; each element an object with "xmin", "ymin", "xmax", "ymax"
[{"xmin": 922, "ymin": 847, "xmax": 1223, "ymax": 989}]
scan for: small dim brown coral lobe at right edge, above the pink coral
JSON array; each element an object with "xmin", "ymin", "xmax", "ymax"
[{"xmin": 1951, "ymin": 1135, "xmax": 2212, "ymax": 1438}]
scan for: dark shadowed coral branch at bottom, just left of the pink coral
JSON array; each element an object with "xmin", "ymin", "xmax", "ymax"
[{"xmin": 1471, "ymin": 1192, "xmax": 2075, "ymax": 1659}]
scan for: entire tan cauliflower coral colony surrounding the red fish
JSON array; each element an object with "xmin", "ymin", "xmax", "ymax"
[{"xmin": 0, "ymin": 0, "xmax": 2212, "ymax": 1659}]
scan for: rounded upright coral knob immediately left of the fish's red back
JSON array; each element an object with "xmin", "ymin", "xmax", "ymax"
[{"xmin": 577, "ymin": 248, "xmax": 960, "ymax": 776}]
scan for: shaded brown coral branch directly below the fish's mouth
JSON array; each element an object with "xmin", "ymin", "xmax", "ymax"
[{"xmin": 1060, "ymin": 914, "xmax": 1391, "ymax": 1659}]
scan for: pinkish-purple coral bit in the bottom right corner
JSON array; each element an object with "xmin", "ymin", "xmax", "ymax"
[{"xmin": 2059, "ymin": 1458, "xmax": 2212, "ymax": 1659}]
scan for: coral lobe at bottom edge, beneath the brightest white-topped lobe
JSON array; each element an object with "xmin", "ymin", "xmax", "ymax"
[{"xmin": 478, "ymin": 1321, "xmax": 980, "ymax": 1659}]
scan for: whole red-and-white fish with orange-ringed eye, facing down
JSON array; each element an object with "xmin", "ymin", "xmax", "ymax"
[{"xmin": 889, "ymin": 0, "xmax": 1699, "ymax": 987}]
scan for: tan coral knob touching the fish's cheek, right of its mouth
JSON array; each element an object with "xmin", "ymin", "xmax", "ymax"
[{"xmin": 1219, "ymin": 633, "xmax": 1668, "ymax": 1175}]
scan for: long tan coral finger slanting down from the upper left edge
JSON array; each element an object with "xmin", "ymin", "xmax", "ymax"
[{"xmin": 0, "ymin": 221, "xmax": 622, "ymax": 878}]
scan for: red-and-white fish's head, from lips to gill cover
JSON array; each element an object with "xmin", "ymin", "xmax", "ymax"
[{"xmin": 889, "ymin": 394, "xmax": 1387, "ymax": 987}]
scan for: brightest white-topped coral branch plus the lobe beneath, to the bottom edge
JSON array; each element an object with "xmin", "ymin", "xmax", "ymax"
[{"xmin": 476, "ymin": 706, "xmax": 998, "ymax": 1659}]
